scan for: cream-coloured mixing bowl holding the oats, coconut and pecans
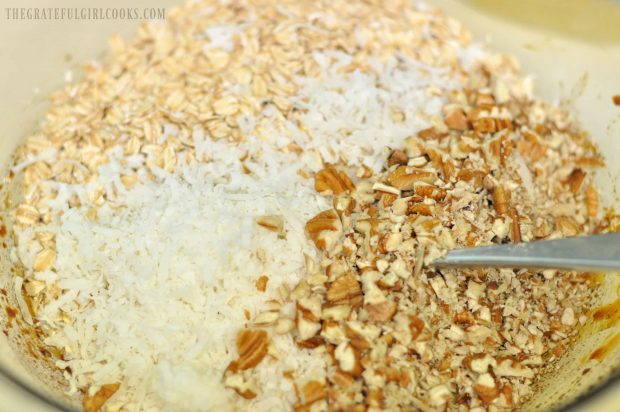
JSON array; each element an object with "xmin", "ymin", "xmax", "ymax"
[{"xmin": 0, "ymin": 0, "xmax": 620, "ymax": 412}]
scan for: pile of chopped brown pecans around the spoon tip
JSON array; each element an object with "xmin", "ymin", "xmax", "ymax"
[{"xmin": 242, "ymin": 81, "xmax": 600, "ymax": 411}]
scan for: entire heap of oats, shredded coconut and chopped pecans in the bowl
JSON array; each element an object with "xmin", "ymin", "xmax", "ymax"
[{"xmin": 2, "ymin": 0, "xmax": 602, "ymax": 411}]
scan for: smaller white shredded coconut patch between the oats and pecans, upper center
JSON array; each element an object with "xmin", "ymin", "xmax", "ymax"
[{"xmin": 296, "ymin": 52, "xmax": 456, "ymax": 171}]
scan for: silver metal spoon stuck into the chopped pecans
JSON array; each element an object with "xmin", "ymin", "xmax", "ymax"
[{"xmin": 431, "ymin": 233, "xmax": 620, "ymax": 272}]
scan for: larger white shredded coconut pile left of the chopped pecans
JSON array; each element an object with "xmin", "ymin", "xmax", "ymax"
[{"xmin": 40, "ymin": 142, "xmax": 327, "ymax": 409}]
